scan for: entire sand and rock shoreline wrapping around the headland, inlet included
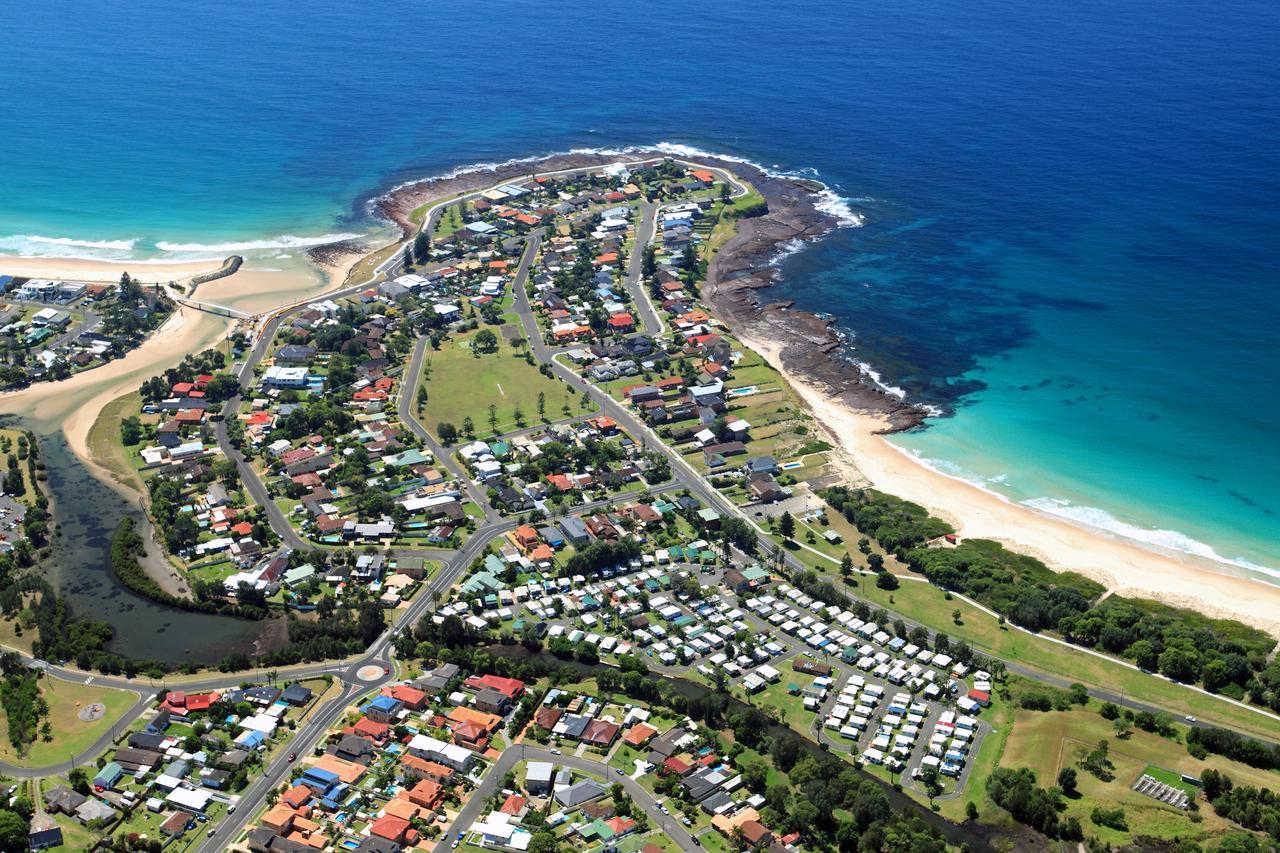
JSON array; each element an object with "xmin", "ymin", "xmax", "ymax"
[{"xmin": 0, "ymin": 149, "xmax": 1280, "ymax": 637}]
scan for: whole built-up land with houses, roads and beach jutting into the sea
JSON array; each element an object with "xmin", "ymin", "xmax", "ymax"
[{"xmin": 0, "ymin": 150, "xmax": 1280, "ymax": 852}]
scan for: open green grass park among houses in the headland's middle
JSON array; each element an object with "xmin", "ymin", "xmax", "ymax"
[{"xmin": 421, "ymin": 333, "xmax": 577, "ymax": 435}]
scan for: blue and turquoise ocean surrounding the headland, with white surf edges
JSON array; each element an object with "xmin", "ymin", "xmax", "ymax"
[{"xmin": 0, "ymin": 0, "xmax": 1280, "ymax": 578}]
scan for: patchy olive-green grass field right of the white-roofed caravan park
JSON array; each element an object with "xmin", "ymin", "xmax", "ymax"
[{"xmin": 1001, "ymin": 708, "xmax": 1280, "ymax": 844}]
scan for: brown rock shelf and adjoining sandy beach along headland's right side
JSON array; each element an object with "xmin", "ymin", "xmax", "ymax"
[{"xmin": 703, "ymin": 168, "xmax": 1280, "ymax": 637}]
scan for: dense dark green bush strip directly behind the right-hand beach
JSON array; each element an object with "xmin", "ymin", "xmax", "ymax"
[{"xmin": 823, "ymin": 487, "xmax": 1280, "ymax": 710}]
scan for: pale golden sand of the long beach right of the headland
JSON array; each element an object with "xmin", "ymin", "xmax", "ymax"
[{"xmin": 739, "ymin": 334, "xmax": 1280, "ymax": 637}]
